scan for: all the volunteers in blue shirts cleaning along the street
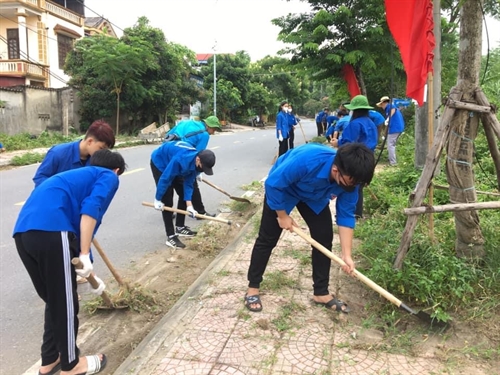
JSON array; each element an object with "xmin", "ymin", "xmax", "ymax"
[{"xmin": 9, "ymin": 95, "xmax": 404, "ymax": 375}]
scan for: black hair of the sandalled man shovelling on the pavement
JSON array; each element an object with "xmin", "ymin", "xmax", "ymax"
[{"xmin": 333, "ymin": 143, "xmax": 375, "ymax": 185}]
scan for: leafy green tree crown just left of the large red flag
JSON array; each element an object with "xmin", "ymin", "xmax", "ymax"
[{"xmin": 273, "ymin": 0, "xmax": 404, "ymax": 99}]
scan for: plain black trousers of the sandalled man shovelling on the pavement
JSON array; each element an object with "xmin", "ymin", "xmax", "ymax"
[{"xmin": 248, "ymin": 197, "xmax": 333, "ymax": 296}]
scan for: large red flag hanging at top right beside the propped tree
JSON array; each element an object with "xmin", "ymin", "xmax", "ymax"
[{"xmin": 385, "ymin": 0, "xmax": 436, "ymax": 105}]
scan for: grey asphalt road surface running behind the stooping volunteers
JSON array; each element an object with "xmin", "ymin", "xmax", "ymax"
[{"xmin": 0, "ymin": 120, "xmax": 316, "ymax": 375}]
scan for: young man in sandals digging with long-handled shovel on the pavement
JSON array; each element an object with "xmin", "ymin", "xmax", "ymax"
[{"xmin": 245, "ymin": 143, "xmax": 375, "ymax": 313}]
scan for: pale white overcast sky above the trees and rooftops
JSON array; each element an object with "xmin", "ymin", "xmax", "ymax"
[{"xmin": 85, "ymin": 0, "xmax": 500, "ymax": 61}]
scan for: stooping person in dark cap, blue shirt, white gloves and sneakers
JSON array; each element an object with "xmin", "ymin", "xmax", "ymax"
[{"xmin": 150, "ymin": 141, "xmax": 215, "ymax": 248}]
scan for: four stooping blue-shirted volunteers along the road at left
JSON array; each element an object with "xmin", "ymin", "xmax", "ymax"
[{"xmin": 13, "ymin": 116, "xmax": 222, "ymax": 375}]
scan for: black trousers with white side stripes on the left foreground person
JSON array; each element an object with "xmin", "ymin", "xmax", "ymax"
[{"xmin": 14, "ymin": 230, "xmax": 80, "ymax": 371}]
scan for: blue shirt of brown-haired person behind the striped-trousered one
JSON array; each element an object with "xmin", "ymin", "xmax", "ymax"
[{"xmin": 33, "ymin": 141, "xmax": 90, "ymax": 188}]
